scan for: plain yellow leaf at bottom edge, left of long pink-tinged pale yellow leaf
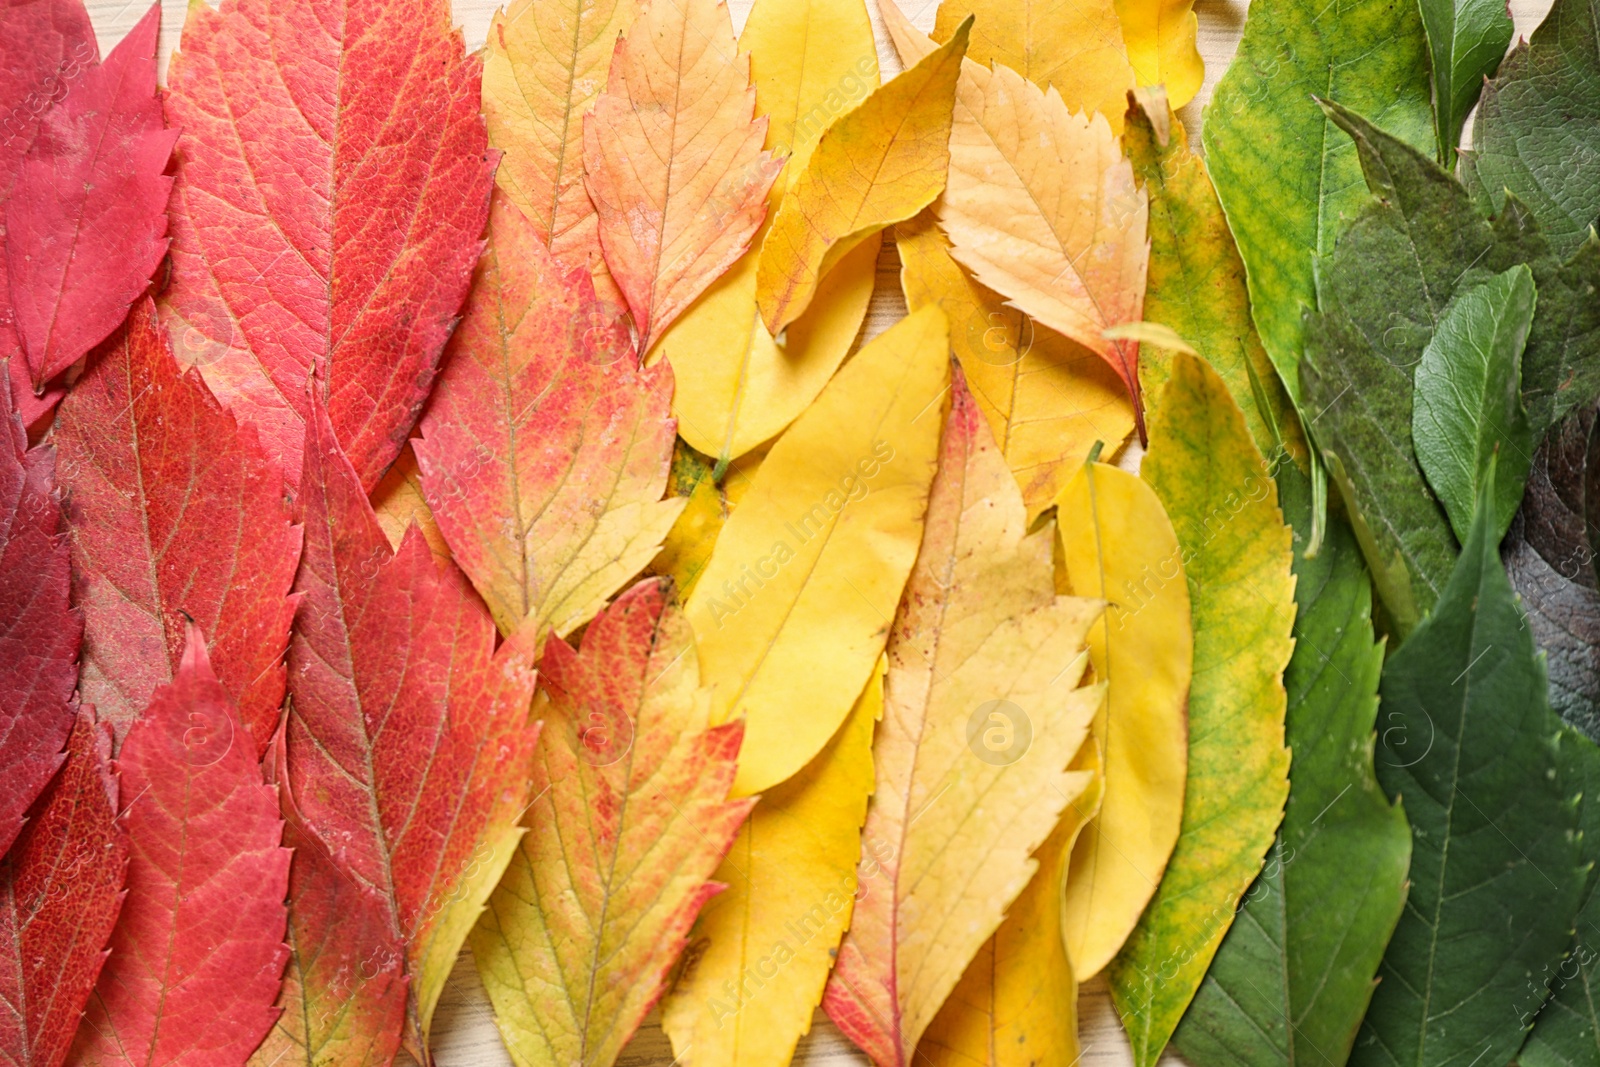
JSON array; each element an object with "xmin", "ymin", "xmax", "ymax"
[{"xmin": 661, "ymin": 661, "xmax": 883, "ymax": 1067}]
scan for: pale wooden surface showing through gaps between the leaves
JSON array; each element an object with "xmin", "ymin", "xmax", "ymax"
[{"xmin": 72, "ymin": 0, "xmax": 1550, "ymax": 1067}]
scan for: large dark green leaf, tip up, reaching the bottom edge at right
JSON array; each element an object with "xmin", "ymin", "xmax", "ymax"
[{"xmin": 1350, "ymin": 470, "xmax": 1587, "ymax": 1067}]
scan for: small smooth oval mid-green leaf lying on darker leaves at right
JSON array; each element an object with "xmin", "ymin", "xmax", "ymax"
[{"xmin": 1411, "ymin": 266, "xmax": 1536, "ymax": 544}]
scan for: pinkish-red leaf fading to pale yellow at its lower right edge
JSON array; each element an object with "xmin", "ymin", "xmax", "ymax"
[{"xmin": 413, "ymin": 192, "xmax": 682, "ymax": 635}]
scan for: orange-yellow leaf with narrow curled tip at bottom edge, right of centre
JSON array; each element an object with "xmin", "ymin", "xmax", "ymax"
[{"xmin": 917, "ymin": 744, "xmax": 1104, "ymax": 1067}]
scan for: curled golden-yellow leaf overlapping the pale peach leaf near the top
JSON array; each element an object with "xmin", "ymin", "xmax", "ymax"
[{"xmin": 757, "ymin": 24, "xmax": 971, "ymax": 334}]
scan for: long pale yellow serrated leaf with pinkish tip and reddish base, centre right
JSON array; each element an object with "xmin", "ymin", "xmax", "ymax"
[{"xmin": 819, "ymin": 369, "xmax": 1104, "ymax": 1067}]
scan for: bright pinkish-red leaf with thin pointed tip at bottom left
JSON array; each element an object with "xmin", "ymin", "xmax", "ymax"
[{"xmin": 72, "ymin": 624, "xmax": 290, "ymax": 1067}]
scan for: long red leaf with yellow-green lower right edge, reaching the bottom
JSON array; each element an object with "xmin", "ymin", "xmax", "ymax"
[{"xmin": 283, "ymin": 405, "xmax": 538, "ymax": 1059}]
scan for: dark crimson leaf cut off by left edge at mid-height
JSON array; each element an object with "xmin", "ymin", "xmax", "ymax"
[{"xmin": 0, "ymin": 363, "xmax": 83, "ymax": 856}]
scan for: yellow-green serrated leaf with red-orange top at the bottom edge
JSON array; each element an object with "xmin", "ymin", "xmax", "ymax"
[{"xmin": 472, "ymin": 579, "xmax": 755, "ymax": 1067}]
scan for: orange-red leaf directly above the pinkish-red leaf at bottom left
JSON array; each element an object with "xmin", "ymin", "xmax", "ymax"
[{"xmin": 54, "ymin": 299, "xmax": 301, "ymax": 755}]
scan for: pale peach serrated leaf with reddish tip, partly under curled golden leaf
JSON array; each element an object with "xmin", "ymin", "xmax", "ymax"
[{"xmin": 880, "ymin": 0, "xmax": 1150, "ymax": 435}]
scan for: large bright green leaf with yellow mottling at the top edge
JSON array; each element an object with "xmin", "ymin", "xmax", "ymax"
[{"xmin": 1205, "ymin": 0, "xmax": 1432, "ymax": 400}]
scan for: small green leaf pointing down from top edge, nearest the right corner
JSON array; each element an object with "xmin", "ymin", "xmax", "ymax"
[{"xmin": 1419, "ymin": 0, "xmax": 1515, "ymax": 166}]
